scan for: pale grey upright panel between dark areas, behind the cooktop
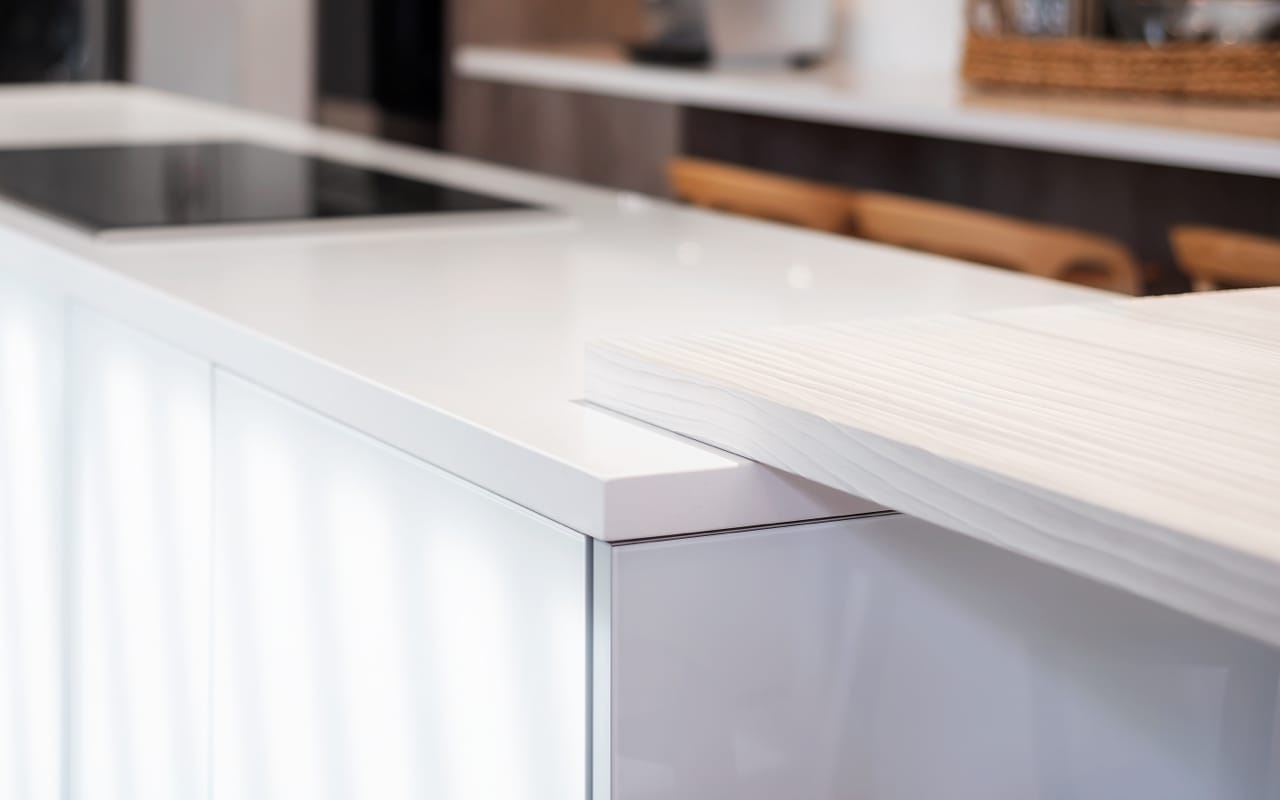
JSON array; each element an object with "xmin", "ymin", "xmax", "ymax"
[{"xmin": 128, "ymin": 0, "xmax": 315, "ymax": 119}]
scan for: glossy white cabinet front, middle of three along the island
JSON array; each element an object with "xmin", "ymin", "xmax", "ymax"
[{"xmin": 69, "ymin": 306, "xmax": 212, "ymax": 800}]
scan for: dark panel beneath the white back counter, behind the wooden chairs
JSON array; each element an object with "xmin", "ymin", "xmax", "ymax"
[{"xmin": 682, "ymin": 109, "xmax": 1280, "ymax": 292}]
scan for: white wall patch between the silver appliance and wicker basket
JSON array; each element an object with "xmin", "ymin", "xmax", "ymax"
[{"xmin": 837, "ymin": 0, "xmax": 965, "ymax": 73}]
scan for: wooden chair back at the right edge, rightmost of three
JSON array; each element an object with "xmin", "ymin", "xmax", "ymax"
[{"xmin": 1169, "ymin": 225, "xmax": 1280, "ymax": 292}]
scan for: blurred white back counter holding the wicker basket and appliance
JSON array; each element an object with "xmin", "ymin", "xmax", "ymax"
[{"xmin": 456, "ymin": 46, "xmax": 1280, "ymax": 178}]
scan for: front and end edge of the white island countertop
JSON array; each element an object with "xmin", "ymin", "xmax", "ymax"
[{"xmin": 0, "ymin": 227, "xmax": 869, "ymax": 541}]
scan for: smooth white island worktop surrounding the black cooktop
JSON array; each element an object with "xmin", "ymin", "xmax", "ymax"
[{"xmin": 0, "ymin": 84, "xmax": 1107, "ymax": 540}]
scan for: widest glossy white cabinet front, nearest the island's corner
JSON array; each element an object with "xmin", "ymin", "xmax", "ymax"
[{"xmin": 212, "ymin": 372, "xmax": 588, "ymax": 800}]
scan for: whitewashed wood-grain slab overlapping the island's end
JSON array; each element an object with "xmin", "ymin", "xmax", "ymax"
[{"xmin": 588, "ymin": 289, "xmax": 1280, "ymax": 644}]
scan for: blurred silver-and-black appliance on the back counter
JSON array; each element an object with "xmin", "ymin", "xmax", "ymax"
[{"xmin": 631, "ymin": 0, "xmax": 833, "ymax": 65}]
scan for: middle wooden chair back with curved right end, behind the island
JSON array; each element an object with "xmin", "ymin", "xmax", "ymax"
[{"xmin": 849, "ymin": 192, "xmax": 1143, "ymax": 294}]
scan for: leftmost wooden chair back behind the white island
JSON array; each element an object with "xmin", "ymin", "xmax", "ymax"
[{"xmin": 668, "ymin": 157, "xmax": 849, "ymax": 233}]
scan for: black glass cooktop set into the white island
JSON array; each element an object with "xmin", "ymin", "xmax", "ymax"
[{"xmin": 0, "ymin": 142, "xmax": 530, "ymax": 233}]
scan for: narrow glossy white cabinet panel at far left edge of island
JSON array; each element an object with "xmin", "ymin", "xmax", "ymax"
[{"xmin": 0, "ymin": 265, "xmax": 64, "ymax": 800}]
